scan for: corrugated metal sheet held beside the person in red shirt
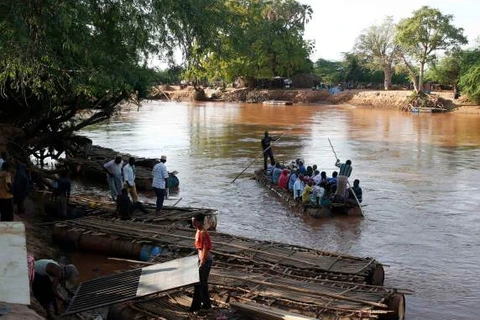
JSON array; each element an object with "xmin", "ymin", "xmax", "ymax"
[{"xmin": 64, "ymin": 256, "xmax": 199, "ymax": 315}]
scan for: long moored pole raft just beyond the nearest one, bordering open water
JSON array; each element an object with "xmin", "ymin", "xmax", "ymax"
[{"xmin": 53, "ymin": 216, "xmax": 385, "ymax": 285}]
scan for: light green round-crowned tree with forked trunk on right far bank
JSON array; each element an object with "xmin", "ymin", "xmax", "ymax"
[{"xmin": 396, "ymin": 6, "xmax": 467, "ymax": 91}]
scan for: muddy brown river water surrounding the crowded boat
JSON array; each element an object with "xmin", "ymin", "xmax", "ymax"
[{"xmin": 77, "ymin": 102, "xmax": 480, "ymax": 319}]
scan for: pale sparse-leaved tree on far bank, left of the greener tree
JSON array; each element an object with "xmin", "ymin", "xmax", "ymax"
[{"xmin": 355, "ymin": 17, "xmax": 399, "ymax": 90}]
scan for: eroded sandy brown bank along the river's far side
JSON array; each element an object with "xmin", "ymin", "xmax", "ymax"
[{"xmin": 151, "ymin": 86, "xmax": 480, "ymax": 114}]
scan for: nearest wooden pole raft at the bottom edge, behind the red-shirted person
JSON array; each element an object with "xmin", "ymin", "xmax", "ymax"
[{"xmin": 110, "ymin": 257, "xmax": 411, "ymax": 320}]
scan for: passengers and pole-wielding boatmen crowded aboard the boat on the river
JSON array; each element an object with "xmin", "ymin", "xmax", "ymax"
[{"xmin": 261, "ymin": 131, "xmax": 363, "ymax": 206}]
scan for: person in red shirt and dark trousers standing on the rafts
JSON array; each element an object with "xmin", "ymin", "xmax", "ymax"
[{"xmin": 189, "ymin": 214, "xmax": 213, "ymax": 312}]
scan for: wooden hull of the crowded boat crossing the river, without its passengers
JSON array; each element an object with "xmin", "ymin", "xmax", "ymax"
[{"xmin": 255, "ymin": 169, "xmax": 363, "ymax": 218}]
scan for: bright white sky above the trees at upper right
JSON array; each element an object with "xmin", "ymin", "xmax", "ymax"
[{"xmin": 298, "ymin": 0, "xmax": 480, "ymax": 61}]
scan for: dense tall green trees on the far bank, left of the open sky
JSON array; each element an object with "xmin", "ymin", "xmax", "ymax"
[{"xmin": 186, "ymin": 0, "xmax": 313, "ymax": 81}]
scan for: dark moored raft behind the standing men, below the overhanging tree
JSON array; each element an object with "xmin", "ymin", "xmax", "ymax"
[{"xmin": 59, "ymin": 145, "xmax": 180, "ymax": 192}]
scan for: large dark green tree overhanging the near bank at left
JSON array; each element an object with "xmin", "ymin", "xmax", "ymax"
[{"xmin": 0, "ymin": 0, "xmax": 231, "ymax": 178}]
